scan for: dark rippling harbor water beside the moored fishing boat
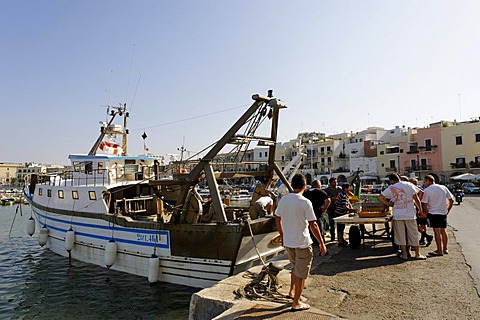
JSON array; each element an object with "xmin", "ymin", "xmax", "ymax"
[{"xmin": 0, "ymin": 205, "xmax": 199, "ymax": 319}]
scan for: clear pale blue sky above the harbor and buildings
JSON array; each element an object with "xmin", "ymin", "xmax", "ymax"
[{"xmin": 0, "ymin": 0, "xmax": 480, "ymax": 164}]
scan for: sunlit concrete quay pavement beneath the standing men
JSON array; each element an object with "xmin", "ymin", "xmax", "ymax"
[{"xmin": 189, "ymin": 227, "xmax": 480, "ymax": 320}]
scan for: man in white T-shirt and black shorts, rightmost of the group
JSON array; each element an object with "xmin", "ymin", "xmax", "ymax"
[{"xmin": 422, "ymin": 175, "xmax": 454, "ymax": 256}]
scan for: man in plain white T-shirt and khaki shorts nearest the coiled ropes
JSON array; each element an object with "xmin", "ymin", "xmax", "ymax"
[{"xmin": 275, "ymin": 174, "xmax": 327, "ymax": 311}]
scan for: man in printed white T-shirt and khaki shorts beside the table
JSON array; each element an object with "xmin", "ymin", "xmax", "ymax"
[{"xmin": 378, "ymin": 173, "xmax": 427, "ymax": 260}]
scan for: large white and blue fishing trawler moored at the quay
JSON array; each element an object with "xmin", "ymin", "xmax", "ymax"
[{"xmin": 25, "ymin": 91, "xmax": 291, "ymax": 288}]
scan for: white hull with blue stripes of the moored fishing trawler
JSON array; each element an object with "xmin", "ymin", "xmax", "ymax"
[{"xmin": 32, "ymin": 206, "xmax": 283, "ymax": 288}]
